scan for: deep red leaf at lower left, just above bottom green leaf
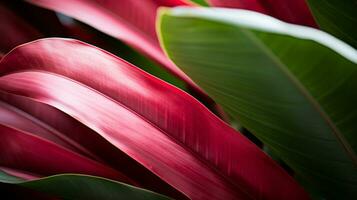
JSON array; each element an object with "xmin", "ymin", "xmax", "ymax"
[{"xmin": 0, "ymin": 124, "xmax": 128, "ymax": 181}]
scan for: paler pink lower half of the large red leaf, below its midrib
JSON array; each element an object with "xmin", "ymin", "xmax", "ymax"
[{"xmin": 0, "ymin": 72, "xmax": 249, "ymax": 199}]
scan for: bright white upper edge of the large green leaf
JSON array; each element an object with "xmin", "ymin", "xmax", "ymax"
[{"xmin": 167, "ymin": 6, "xmax": 357, "ymax": 64}]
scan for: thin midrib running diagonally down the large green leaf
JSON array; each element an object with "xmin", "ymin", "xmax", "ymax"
[{"xmin": 241, "ymin": 29, "xmax": 357, "ymax": 167}]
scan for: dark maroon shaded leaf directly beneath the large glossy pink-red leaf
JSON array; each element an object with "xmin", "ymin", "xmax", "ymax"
[{"xmin": 0, "ymin": 92, "xmax": 182, "ymax": 198}]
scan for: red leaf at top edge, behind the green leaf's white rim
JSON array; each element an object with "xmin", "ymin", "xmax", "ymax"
[{"xmin": 208, "ymin": 0, "xmax": 317, "ymax": 27}]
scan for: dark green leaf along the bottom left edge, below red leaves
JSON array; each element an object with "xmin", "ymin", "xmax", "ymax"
[{"xmin": 0, "ymin": 171, "xmax": 169, "ymax": 200}]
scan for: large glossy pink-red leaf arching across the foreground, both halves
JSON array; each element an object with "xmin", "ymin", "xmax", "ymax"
[{"xmin": 0, "ymin": 39, "xmax": 308, "ymax": 199}]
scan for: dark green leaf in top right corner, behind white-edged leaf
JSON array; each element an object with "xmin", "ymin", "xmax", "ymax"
[{"xmin": 307, "ymin": 0, "xmax": 357, "ymax": 48}]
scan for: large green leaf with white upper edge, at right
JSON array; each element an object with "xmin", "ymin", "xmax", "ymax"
[{"xmin": 159, "ymin": 8, "xmax": 357, "ymax": 199}]
